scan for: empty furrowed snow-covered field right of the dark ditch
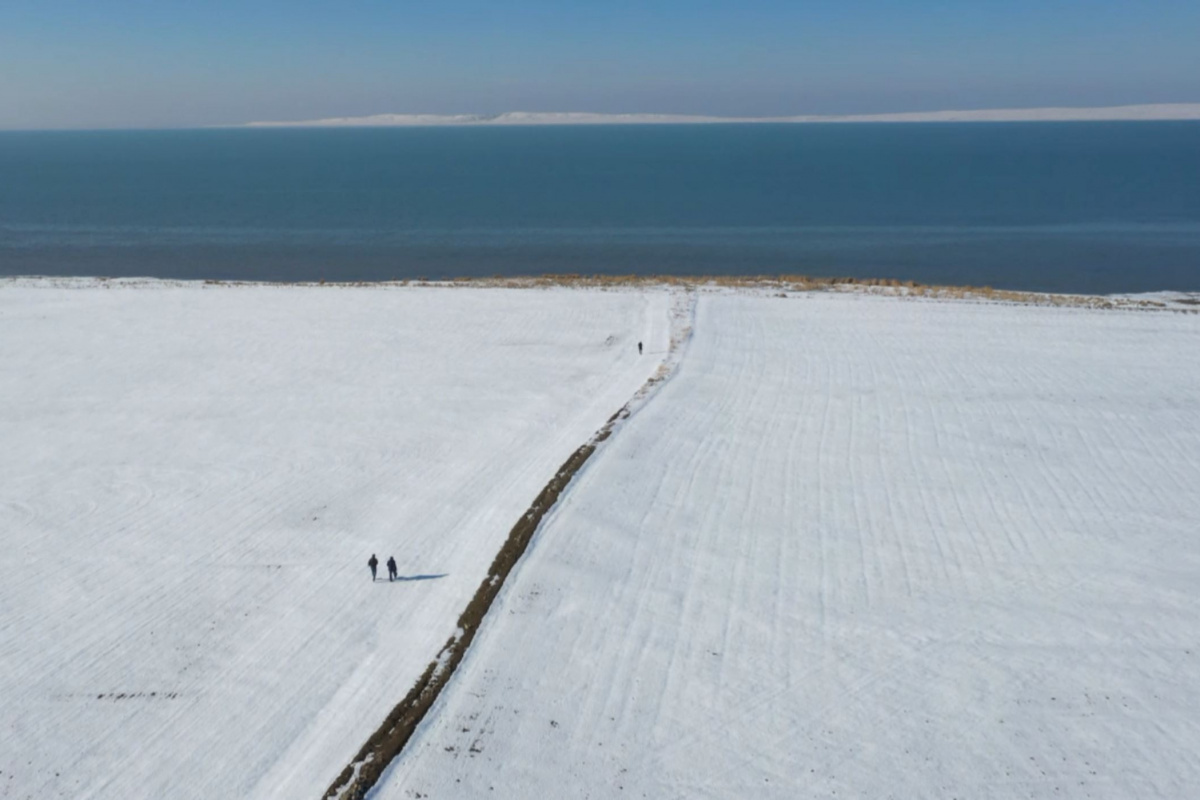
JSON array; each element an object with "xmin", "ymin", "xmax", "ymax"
[{"xmin": 381, "ymin": 294, "xmax": 1200, "ymax": 800}]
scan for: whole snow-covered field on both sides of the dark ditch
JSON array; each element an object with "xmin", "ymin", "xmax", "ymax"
[{"xmin": 0, "ymin": 281, "xmax": 1200, "ymax": 800}]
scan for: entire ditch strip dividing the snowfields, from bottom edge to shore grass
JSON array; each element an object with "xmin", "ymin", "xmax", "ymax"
[{"xmin": 323, "ymin": 290, "xmax": 696, "ymax": 800}]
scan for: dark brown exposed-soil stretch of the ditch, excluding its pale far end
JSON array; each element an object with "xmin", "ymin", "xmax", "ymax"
[{"xmin": 323, "ymin": 404, "xmax": 629, "ymax": 800}]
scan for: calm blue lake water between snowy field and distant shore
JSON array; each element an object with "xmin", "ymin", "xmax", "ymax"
[{"xmin": 0, "ymin": 122, "xmax": 1200, "ymax": 293}]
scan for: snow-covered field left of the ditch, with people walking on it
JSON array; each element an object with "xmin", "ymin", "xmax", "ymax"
[{"xmin": 0, "ymin": 281, "xmax": 668, "ymax": 800}]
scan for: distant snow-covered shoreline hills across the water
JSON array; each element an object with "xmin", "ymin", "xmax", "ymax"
[{"xmin": 239, "ymin": 103, "xmax": 1200, "ymax": 127}]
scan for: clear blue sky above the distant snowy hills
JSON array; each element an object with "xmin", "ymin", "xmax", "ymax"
[{"xmin": 0, "ymin": 0, "xmax": 1200, "ymax": 128}]
